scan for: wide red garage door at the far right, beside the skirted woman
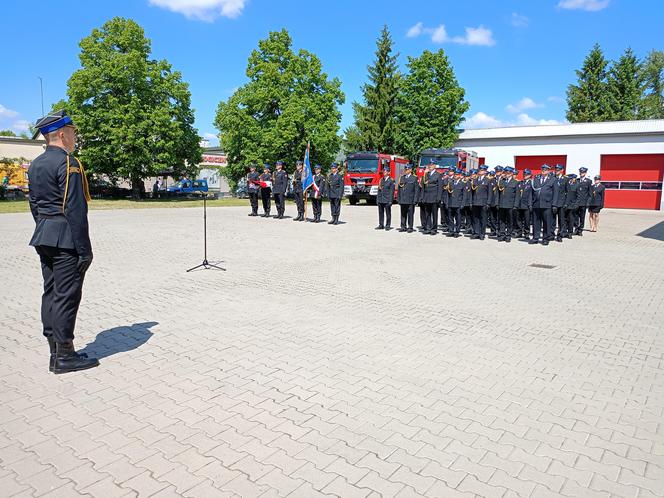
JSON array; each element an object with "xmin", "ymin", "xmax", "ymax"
[{"xmin": 600, "ymin": 154, "xmax": 664, "ymax": 209}]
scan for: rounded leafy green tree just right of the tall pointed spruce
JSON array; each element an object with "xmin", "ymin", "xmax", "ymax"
[{"xmin": 397, "ymin": 49, "xmax": 470, "ymax": 159}]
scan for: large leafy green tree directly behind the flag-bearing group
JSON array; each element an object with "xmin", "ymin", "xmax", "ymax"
[{"xmin": 214, "ymin": 29, "xmax": 344, "ymax": 185}]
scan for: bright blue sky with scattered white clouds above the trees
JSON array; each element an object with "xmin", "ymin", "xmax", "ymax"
[{"xmin": 0, "ymin": 0, "xmax": 664, "ymax": 146}]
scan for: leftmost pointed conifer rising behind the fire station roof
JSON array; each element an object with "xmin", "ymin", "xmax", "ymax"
[{"xmin": 567, "ymin": 43, "xmax": 613, "ymax": 123}]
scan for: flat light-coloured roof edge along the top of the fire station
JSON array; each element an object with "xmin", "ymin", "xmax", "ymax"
[{"xmin": 459, "ymin": 119, "xmax": 664, "ymax": 140}]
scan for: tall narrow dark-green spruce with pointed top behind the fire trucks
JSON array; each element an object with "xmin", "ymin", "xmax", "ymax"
[{"xmin": 345, "ymin": 26, "xmax": 401, "ymax": 152}]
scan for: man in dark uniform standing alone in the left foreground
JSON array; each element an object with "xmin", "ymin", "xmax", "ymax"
[{"xmin": 29, "ymin": 111, "xmax": 99, "ymax": 374}]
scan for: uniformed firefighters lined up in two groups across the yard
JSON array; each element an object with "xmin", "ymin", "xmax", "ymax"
[{"xmin": 247, "ymin": 156, "xmax": 604, "ymax": 241}]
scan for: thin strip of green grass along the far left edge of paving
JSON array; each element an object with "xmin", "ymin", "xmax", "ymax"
[{"xmin": 0, "ymin": 198, "xmax": 249, "ymax": 213}]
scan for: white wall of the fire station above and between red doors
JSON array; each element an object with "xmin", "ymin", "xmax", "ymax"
[{"xmin": 455, "ymin": 134, "xmax": 664, "ymax": 176}]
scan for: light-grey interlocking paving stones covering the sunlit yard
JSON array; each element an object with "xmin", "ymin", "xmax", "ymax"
[{"xmin": 0, "ymin": 206, "xmax": 664, "ymax": 498}]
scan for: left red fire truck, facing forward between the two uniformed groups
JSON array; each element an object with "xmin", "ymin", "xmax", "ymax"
[{"xmin": 344, "ymin": 151, "xmax": 408, "ymax": 205}]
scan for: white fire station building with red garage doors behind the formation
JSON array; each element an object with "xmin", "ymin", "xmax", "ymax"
[{"xmin": 455, "ymin": 119, "xmax": 664, "ymax": 210}]
